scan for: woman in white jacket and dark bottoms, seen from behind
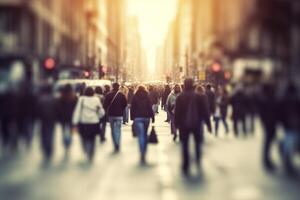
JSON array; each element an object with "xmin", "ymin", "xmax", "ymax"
[{"xmin": 73, "ymin": 87, "xmax": 105, "ymax": 162}]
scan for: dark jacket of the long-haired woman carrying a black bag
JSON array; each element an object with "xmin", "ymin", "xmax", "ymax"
[{"xmin": 130, "ymin": 91, "xmax": 154, "ymax": 121}]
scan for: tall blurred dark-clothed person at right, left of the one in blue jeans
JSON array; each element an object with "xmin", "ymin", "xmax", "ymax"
[{"xmin": 258, "ymin": 84, "xmax": 279, "ymax": 170}]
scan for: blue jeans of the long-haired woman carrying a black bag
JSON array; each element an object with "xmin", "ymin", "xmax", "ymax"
[{"xmin": 134, "ymin": 118, "xmax": 150, "ymax": 155}]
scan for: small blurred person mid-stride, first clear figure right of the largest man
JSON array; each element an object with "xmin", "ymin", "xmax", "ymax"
[{"xmin": 214, "ymin": 88, "xmax": 229, "ymax": 136}]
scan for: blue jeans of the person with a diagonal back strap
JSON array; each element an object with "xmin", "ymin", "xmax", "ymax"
[{"xmin": 108, "ymin": 116, "xmax": 123, "ymax": 151}]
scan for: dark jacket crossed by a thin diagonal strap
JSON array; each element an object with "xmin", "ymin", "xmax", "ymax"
[{"xmin": 103, "ymin": 91, "xmax": 127, "ymax": 117}]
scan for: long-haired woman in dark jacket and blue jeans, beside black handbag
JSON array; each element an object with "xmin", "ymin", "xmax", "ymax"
[{"xmin": 131, "ymin": 86, "xmax": 154, "ymax": 164}]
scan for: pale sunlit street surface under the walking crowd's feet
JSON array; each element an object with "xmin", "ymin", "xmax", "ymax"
[{"xmin": 0, "ymin": 111, "xmax": 300, "ymax": 200}]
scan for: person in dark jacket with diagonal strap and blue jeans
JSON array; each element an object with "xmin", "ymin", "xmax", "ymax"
[{"xmin": 104, "ymin": 83, "xmax": 127, "ymax": 152}]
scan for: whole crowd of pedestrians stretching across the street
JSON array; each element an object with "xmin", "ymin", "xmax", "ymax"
[{"xmin": 0, "ymin": 79, "xmax": 300, "ymax": 176}]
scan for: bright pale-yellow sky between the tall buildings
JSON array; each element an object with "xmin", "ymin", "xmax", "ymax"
[{"xmin": 128, "ymin": 0, "xmax": 177, "ymax": 72}]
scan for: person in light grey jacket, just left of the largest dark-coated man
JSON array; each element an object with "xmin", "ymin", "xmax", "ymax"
[{"xmin": 166, "ymin": 84, "xmax": 181, "ymax": 141}]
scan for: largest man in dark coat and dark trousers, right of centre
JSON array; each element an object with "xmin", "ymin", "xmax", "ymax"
[{"xmin": 174, "ymin": 79, "xmax": 211, "ymax": 176}]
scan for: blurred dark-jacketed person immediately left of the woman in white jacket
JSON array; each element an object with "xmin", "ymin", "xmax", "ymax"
[{"xmin": 57, "ymin": 84, "xmax": 77, "ymax": 155}]
